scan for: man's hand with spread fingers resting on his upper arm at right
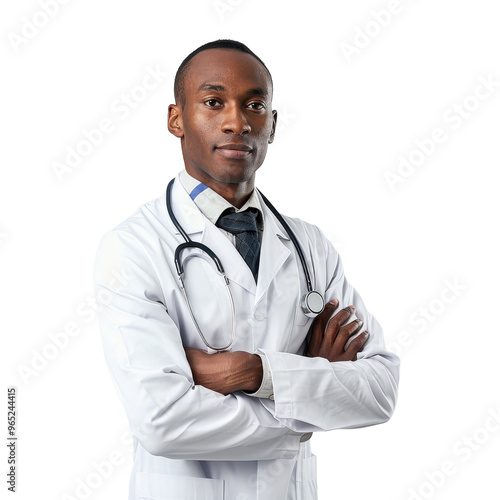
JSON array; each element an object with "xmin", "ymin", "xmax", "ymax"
[{"xmin": 306, "ymin": 300, "xmax": 369, "ymax": 362}]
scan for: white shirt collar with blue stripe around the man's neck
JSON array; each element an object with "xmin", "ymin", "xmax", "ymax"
[{"xmin": 179, "ymin": 170, "xmax": 263, "ymax": 229}]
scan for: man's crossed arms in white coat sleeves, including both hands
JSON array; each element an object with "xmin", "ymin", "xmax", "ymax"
[{"xmin": 95, "ymin": 230, "xmax": 399, "ymax": 460}]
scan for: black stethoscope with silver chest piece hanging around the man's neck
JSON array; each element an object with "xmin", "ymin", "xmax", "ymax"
[{"xmin": 166, "ymin": 179, "xmax": 325, "ymax": 352}]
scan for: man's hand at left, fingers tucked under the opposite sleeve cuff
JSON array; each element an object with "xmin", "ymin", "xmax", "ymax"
[{"xmin": 184, "ymin": 347, "xmax": 262, "ymax": 396}]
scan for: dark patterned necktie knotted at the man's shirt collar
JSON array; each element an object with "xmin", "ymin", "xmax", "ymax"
[{"xmin": 215, "ymin": 207, "xmax": 260, "ymax": 282}]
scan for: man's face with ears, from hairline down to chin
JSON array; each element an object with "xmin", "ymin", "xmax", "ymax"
[{"xmin": 169, "ymin": 49, "xmax": 277, "ymax": 194}]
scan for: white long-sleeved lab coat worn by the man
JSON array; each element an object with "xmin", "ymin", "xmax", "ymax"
[{"xmin": 95, "ymin": 174, "xmax": 399, "ymax": 500}]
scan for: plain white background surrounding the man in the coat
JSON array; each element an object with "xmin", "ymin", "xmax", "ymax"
[{"xmin": 0, "ymin": 0, "xmax": 500, "ymax": 500}]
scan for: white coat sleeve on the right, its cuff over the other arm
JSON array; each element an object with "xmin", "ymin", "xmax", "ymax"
[{"xmin": 261, "ymin": 228, "xmax": 399, "ymax": 432}]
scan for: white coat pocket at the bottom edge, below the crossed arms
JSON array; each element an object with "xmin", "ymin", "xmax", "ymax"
[{"xmin": 135, "ymin": 472, "xmax": 224, "ymax": 500}]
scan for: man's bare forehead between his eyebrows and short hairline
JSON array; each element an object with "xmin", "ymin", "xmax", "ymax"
[{"xmin": 185, "ymin": 49, "xmax": 272, "ymax": 98}]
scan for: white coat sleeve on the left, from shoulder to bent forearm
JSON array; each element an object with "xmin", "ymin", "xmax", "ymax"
[{"xmin": 95, "ymin": 230, "xmax": 300, "ymax": 460}]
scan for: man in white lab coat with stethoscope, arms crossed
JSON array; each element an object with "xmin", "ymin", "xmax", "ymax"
[{"xmin": 95, "ymin": 40, "xmax": 399, "ymax": 500}]
